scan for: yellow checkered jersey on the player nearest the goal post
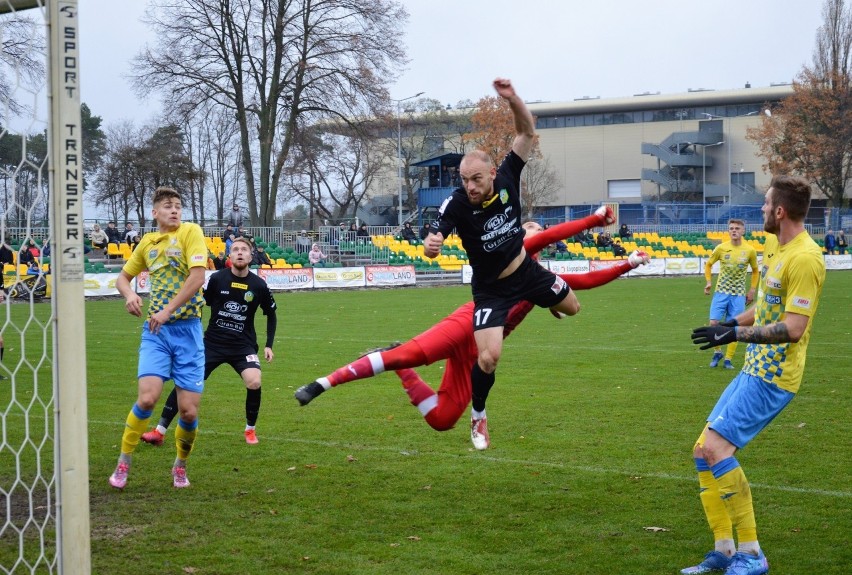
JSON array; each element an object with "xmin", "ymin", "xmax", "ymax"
[{"xmin": 122, "ymin": 222, "xmax": 207, "ymax": 322}]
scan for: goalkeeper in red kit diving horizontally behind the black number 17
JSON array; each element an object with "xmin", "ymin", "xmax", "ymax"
[{"xmin": 295, "ymin": 207, "xmax": 648, "ymax": 449}]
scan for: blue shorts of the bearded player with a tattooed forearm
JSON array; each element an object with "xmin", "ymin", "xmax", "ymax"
[{"xmin": 707, "ymin": 371, "xmax": 796, "ymax": 449}]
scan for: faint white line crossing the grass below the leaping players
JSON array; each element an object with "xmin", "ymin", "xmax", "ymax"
[{"xmin": 89, "ymin": 421, "xmax": 852, "ymax": 498}]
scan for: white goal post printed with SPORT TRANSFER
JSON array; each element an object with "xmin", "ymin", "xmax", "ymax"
[{"xmin": 47, "ymin": 0, "xmax": 91, "ymax": 575}]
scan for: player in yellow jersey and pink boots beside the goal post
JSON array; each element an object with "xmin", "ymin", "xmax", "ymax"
[{"xmin": 109, "ymin": 187, "xmax": 207, "ymax": 489}]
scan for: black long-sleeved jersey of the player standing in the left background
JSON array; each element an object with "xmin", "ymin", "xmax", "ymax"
[{"xmin": 204, "ymin": 268, "xmax": 276, "ymax": 352}]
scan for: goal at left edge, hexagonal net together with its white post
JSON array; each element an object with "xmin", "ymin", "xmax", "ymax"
[{"xmin": 0, "ymin": 0, "xmax": 91, "ymax": 574}]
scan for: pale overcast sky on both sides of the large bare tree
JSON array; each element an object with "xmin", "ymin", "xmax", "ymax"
[{"xmin": 80, "ymin": 0, "xmax": 823, "ymax": 125}]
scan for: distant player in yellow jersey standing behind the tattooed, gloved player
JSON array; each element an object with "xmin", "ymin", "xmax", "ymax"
[{"xmin": 704, "ymin": 219, "xmax": 759, "ymax": 369}]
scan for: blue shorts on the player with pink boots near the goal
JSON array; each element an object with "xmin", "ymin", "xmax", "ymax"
[{"xmin": 137, "ymin": 318, "xmax": 204, "ymax": 393}]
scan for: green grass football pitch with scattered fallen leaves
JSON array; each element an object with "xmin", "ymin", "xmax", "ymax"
[{"xmin": 0, "ymin": 272, "xmax": 852, "ymax": 575}]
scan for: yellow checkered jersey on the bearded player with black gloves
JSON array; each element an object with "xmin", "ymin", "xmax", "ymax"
[{"xmin": 743, "ymin": 232, "xmax": 825, "ymax": 393}]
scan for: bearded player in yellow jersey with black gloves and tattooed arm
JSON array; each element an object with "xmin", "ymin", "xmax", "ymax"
[{"xmin": 681, "ymin": 176, "xmax": 825, "ymax": 575}]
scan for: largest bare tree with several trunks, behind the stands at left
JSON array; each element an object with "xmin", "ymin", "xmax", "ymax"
[{"xmin": 135, "ymin": 0, "xmax": 408, "ymax": 225}]
